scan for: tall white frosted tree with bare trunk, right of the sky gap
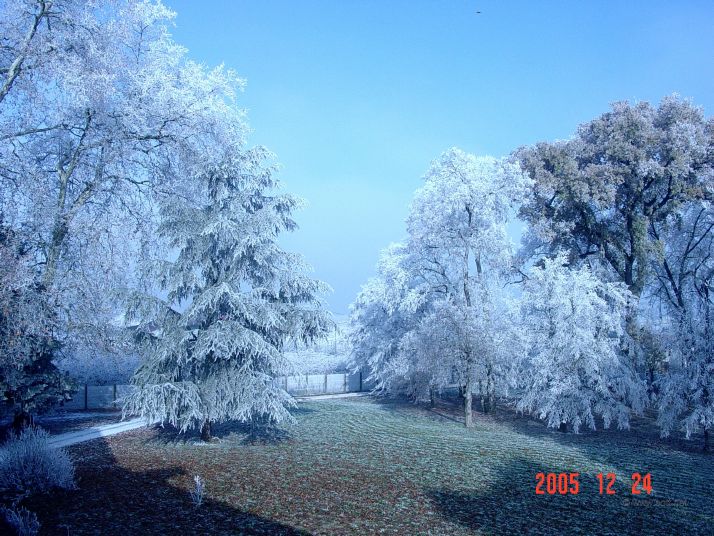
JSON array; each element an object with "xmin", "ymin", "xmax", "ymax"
[{"xmin": 353, "ymin": 148, "xmax": 528, "ymax": 426}]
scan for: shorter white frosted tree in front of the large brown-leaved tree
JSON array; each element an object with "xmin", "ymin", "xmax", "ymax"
[{"xmin": 518, "ymin": 254, "xmax": 646, "ymax": 433}]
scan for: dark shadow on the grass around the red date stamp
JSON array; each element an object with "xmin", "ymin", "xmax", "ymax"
[{"xmin": 420, "ymin": 459, "xmax": 711, "ymax": 536}]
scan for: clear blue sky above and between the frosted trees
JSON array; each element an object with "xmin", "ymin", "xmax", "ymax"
[{"xmin": 165, "ymin": 0, "xmax": 714, "ymax": 313}]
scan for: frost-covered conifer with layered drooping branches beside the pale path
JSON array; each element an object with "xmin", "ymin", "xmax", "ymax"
[{"xmin": 125, "ymin": 148, "xmax": 331, "ymax": 440}]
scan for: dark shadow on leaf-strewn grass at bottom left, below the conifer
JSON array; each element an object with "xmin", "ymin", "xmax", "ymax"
[{"xmin": 24, "ymin": 440, "xmax": 309, "ymax": 535}]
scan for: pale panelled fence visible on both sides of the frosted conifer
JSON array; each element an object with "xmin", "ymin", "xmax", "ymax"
[{"xmin": 63, "ymin": 372, "xmax": 372, "ymax": 410}]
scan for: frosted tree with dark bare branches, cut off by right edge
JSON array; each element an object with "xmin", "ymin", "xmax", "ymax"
[{"xmin": 652, "ymin": 202, "xmax": 714, "ymax": 450}]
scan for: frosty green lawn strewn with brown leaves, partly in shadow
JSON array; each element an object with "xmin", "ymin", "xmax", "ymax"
[{"xmin": 27, "ymin": 398, "xmax": 714, "ymax": 535}]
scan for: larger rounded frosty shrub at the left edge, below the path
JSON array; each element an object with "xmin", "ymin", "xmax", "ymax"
[{"xmin": 0, "ymin": 427, "xmax": 74, "ymax": 501}]
